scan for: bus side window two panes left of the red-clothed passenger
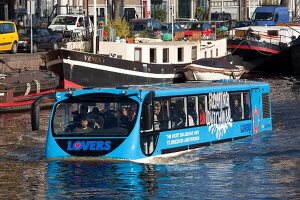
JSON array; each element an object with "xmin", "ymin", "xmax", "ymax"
[{"xmin": 171, "ymin": 97, "xmax": 187, "ymax": 129}]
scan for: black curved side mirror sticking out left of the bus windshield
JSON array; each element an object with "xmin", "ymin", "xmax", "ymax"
[{"xmin": 31, "ymin": 93, "xmax": 55, "ymax": 131}]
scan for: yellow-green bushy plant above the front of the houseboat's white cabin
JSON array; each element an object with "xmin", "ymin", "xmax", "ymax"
[{"xmin": 104, "ymin": 18, "xmax": 131, "ymax": 38}]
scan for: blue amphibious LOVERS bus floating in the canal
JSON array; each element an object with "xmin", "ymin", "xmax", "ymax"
[{"xmin": 32, "ymin": 80, "xmax": 272, "ymax": 162}]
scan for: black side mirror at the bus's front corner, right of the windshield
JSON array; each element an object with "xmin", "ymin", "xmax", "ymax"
[{"xmin": 143, "ymin": 91, "xmax": 155, "ymax": 130}]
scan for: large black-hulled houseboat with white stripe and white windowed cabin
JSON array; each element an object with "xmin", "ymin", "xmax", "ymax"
[{"xmin": 45, "ymin": 39, "xmax": 227, "ymax": 88}]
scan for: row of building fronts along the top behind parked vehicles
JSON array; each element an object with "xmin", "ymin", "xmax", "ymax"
[{"xmin": 0, "ymin": 0, "xmax": 300, "ymax": 25}]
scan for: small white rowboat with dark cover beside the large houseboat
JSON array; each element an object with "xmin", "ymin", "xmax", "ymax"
[{"xmin": 183, "ymin": 57, "xmax": 245, "ymax": 81}]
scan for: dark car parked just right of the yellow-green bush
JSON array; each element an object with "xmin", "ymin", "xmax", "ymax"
[{"xmin": 129, "ymin": 18, "xmax": 162, "ymax": 38}]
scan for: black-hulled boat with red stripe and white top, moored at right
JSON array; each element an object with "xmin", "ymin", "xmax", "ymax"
[{"xmin": 227, "ymin": 26, "xmax": 295, "ymax": 74}]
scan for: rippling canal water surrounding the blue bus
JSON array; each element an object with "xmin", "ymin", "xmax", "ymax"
[{"xmin": 0, "ymin": 77, "xmax": 300, "ymax": 199}]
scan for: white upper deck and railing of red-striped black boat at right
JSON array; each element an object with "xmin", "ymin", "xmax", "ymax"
[{"xmin": 229, "ymin": 29, "xmax": 294, "ymax": 44}]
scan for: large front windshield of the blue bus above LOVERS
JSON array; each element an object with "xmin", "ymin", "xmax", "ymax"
[{"xmin": 52, "ymin": 97, "xmax": 138, "ymax": 136}]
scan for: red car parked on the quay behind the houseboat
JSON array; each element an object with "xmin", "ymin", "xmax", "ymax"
[{"xmin": 184, "ymin": 22, "xmax": 214, "ymax": 38}]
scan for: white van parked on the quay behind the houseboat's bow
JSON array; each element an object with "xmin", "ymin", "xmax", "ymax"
[{"xmin": 49, "ymin": 15, "xmax": 93, "ymax": 36}]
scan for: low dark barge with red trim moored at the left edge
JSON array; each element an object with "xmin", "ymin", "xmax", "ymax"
[{"xmin": 0, "ymin": 66, "xmax": 59, "ymax": 112}]
